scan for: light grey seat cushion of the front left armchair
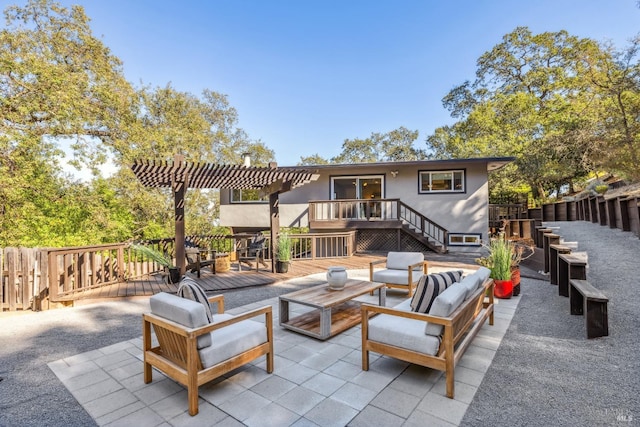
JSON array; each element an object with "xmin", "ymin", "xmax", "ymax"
[{"xmin": 198, "ymin": 320, "xmax": 267, "ymax": 368}]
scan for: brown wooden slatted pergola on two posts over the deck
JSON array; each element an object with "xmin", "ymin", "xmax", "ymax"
[{"xmin": 131, "ymin": 155, "xmax": 318, "ymax": 274}]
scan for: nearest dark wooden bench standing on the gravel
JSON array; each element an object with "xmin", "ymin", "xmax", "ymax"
[{"xmin": 569, "ymin": 279, "xmax": 609, "ymax": 338}]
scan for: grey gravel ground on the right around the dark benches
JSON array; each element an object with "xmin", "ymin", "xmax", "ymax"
[{"xmin": 461, "ymin": 221, "xmax": 640, "ymax": 427}]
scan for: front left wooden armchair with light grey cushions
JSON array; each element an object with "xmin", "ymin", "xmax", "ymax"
[{"xmin": 142, "ymin": 292, "xmax": 273, "ymax": 416}]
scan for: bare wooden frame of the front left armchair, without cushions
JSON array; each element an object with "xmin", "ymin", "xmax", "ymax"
[{"xmin": 142, "ymin": 295, "xmax": 274, "ymax": 416}]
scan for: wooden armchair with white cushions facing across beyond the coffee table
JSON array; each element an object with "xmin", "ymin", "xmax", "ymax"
[{"xmin": 369, "ymin": 252, "xmax": 428, "ymax": 297}]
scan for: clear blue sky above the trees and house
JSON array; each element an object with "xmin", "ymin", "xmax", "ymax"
[{"xmin": 55, "ymin": 0, "xmax": 640, "ymax": 166}]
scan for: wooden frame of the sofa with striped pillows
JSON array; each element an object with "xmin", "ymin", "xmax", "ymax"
[{"xmin": 361, "ymin": 279, "xmax": 494, "ymax": 399}]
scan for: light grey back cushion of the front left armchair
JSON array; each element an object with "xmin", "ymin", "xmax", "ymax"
[{"xmin": 149, "ymin": 292, "xmax": 212, "ymax": 349}]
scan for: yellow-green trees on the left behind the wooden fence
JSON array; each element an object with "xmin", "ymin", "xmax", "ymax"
[{"xmin": 0, "ymin": 0, "xmax": 274, "ymax": 246}]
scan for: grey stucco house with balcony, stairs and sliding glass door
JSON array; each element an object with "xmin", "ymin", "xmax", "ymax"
[{"xmin": 220, "ymin": 157, "xmax": 513, "ymax": 252}]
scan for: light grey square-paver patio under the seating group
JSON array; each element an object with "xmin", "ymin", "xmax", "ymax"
[{"xmin": 48, "ymin": 270, "xmax": 526, "ymax": 426}]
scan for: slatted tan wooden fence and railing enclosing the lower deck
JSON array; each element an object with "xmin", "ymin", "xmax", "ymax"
[{"xmin": 0, "ymin": 232, "xmax": 356, "ymax": 311}]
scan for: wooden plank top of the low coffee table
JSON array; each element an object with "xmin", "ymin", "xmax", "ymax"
[{"xmin": 280, "ymin": 279, "xmax": 384, "ymax": 308}]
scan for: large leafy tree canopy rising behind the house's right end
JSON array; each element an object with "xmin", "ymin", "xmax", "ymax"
[{"xmin": 427, "ymin": 27, "xmax": 640, "ymax": 204}]
